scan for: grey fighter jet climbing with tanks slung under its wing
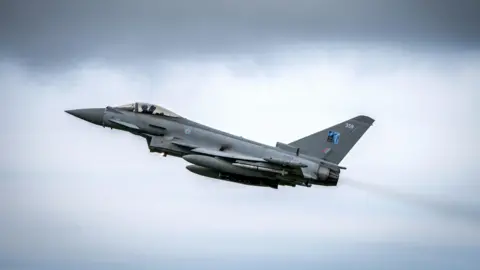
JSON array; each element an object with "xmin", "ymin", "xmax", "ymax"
[{"xmin": 65, "ymin": 102, "xmax": 374, "ymax": 189}]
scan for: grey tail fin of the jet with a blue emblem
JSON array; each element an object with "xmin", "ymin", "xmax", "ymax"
[{"xmin": 290, "ymin": 115, "xmax": 375, "ymax": 164}]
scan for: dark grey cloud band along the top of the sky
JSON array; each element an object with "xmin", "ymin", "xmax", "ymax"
[{"xmin": 0, "ymin": 0, "xmax": 480, "ymax": 66}]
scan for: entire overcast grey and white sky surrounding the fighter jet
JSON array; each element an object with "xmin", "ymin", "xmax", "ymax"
[{"xmin": 0, "ymin": 0, "xmax": 480, "ymax": 269}]
